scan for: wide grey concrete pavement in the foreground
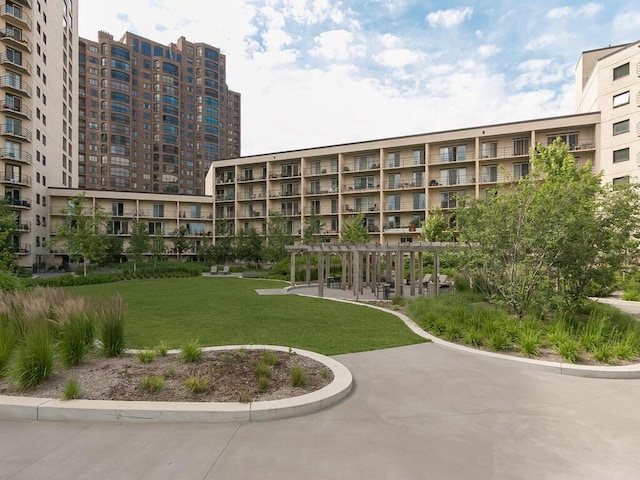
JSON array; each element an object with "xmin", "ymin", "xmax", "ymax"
[{"xmin": 0, "ymin": 343, "xmax": 640, "ymax": 480}]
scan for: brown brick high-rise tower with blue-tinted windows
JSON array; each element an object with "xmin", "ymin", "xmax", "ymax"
[{"xmin": 78, "ymin": 32, "xmax": 240, "ymax": 195}]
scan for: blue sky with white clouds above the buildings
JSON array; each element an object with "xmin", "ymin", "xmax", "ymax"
[{"xmin": 78, "ymin": 0, "xmax": 640, "ymax": 156}]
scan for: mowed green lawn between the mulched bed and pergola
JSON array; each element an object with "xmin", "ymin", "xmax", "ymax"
[{"xmin": 67, "ymin": 277, "xmax": 424, "ymax": 355}]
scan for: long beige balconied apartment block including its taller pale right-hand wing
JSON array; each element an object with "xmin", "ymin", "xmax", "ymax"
[{"xmin": 42, "ymin": 42, "xmax": 640, "ymax": 263}]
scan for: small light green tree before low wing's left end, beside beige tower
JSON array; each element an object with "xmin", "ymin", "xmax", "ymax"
[{"xmin": 56, "ymin": 193, "xmax": 108, "ymax": 276}]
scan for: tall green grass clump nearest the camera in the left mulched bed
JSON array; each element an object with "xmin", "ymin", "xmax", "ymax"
[{"xmin": 9, "ymin": 326, "xmax": 55, "ymax": 390}]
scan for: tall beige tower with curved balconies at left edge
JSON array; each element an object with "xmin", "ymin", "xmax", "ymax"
[{"xmin": 0, "ymin": 0, "xmax": 78, "ymax": 268}]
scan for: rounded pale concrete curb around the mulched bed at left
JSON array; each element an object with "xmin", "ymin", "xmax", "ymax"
[{"xmin": 0, "ymin": 345, "xmax": 353, "ymax": 423}]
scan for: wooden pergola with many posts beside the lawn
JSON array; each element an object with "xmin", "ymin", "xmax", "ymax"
[{"xmin": 285, "ymin": 242, "xmax": 461, "ymax": 298}]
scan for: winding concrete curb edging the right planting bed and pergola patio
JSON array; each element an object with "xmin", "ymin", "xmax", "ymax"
[{"xmin": 294, "ymin": 294, "xmax": 640, "ymax": 379}]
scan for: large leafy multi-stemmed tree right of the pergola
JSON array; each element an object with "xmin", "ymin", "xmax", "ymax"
[{"xmin": 457, "ymin": 139, "xmax": 626, "ymax": 316}]
